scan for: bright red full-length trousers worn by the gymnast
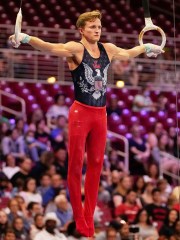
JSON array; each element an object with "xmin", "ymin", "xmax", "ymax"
[{"xmin": 68, "ymin": 101, "xmax": 107, "ymax": 237}]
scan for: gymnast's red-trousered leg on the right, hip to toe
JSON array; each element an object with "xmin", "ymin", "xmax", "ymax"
[{"xmin": 84, "ymin": 110, "xmax": 107, "ymax": 237}]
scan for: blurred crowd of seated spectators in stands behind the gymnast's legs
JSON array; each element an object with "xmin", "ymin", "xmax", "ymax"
[{"xmin": 0, "ymin": 90, "xmax": 180, "ymax": 240}]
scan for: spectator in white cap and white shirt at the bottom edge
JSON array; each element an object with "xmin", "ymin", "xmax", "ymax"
[{"xmin": 34, "ymin": 212, "xmax": 67, "ymax": 240}]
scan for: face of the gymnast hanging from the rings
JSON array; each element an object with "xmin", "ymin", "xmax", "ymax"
[{"xmin": 80, "ymin": 18, "xmax": 102, "ymax": 42}]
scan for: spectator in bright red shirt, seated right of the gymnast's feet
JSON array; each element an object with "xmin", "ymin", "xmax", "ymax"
[{"xmin": 115, "ymin": 190, "xmax": 141, "ymax": 223}]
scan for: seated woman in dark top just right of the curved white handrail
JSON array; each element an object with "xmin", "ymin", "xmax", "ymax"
[{"xmin": 129, "ymin": 124, "xmax": 150, "ymax": 175}]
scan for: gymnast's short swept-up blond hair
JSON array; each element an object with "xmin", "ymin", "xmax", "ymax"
[{"xmin": 76, "ymin": 10, "xmax": 102, "ymax": 28}]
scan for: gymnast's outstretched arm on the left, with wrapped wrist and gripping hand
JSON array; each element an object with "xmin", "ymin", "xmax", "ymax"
[{"xmin": 9, "ymin": 33, "xmax": 81, "ymax": 57}]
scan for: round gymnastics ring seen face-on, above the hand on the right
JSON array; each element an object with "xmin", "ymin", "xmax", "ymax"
[{"xmin": 139, "ymin": 18, "xmax": 166, "ymax": 49}]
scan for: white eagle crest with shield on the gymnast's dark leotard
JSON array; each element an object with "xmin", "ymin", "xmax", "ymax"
[{"xmin": 81, "ymin": 62, "xmax": 109, "ymax": 100}]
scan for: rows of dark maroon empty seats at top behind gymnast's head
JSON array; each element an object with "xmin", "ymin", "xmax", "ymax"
[{"xmin": 0, "ymin": 0, "xmax": 179, "ymax": 36}]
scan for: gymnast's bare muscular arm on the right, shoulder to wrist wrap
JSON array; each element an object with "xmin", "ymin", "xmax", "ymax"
[{"xmin": 104, "ymin": 43, "xmax": 145, "ymax": 60}]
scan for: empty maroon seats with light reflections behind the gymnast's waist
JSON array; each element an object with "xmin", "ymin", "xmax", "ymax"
[{"xmin": 0, "ymin": 81, "xmax": 180, "ymax": 136}]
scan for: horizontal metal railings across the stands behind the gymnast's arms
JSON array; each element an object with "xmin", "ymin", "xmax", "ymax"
[{"xmin": 0, "ymin": 24, "xmax": 180, "ymax": 89}]
